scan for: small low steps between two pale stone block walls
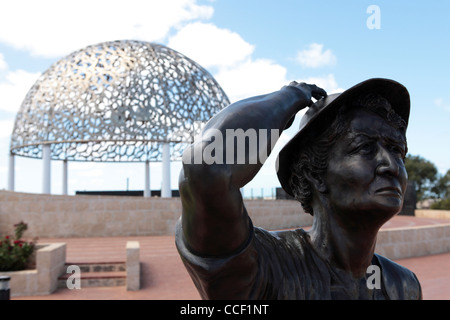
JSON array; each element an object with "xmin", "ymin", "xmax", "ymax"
[{"xmin": 58, "ymin": 262, "xmax": 127, "ymax": 288}]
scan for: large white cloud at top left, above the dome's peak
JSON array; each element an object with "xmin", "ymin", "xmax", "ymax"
[{"xmin": 0, "ymin": 0, "xmax": 213, "ymax": 58}]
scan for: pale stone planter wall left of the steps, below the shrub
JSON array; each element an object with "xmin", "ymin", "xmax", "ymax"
[{"xmin": 0, "ymin": 243, "xmax": 66, "ymax": 297}]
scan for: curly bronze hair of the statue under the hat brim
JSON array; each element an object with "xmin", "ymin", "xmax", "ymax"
[{"xmin": 289, "ymin": 93, "xmax": 406, "ymax": 215}]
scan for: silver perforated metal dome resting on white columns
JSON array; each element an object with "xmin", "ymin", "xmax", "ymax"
[{"xmin": 11, "ymin": 40, "xmax": 229, "ymax": 162}]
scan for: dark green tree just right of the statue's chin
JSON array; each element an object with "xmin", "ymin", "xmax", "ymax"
[{"xmin": 405, "ymin": 154, "xmax": 438, "ymax": 201}]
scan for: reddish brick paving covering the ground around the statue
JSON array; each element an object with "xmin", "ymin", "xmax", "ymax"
[{"xmin": 12, "ymin": 216, "xmax": 450, "ymax": 300}]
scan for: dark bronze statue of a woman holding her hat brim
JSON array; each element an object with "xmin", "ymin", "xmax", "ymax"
[{"xmin": 176, "ymin": 79, "xmax": 422, "ymax": 300}]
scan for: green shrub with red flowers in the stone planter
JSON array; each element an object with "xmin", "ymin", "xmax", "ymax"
[{"xmin": 0, "ymin": 222, "xmax": 35, "ymax": 271}]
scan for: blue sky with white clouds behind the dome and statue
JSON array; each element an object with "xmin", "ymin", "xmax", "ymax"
[{"xmin": 0, "ymin": 0, "xmax": 450, "ymax": 198}]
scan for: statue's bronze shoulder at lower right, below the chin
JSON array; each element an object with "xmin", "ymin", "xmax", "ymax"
[{"xmin": 375, "ymin": 254, "xmax": 422, "ymax": 300}]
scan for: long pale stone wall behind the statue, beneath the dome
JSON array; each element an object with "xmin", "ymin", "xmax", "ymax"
[{"xmin": 0, "ymin": 191, "xmax": 312, "ymax": 238}]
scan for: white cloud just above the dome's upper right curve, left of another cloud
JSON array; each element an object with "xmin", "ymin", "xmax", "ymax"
[{"xmin": 168, "ymin": 22, "xmax": 254, "ymax": 68}]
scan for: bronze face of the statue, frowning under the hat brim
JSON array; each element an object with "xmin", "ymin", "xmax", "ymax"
[{"xmin": 326, "ymin": 110, "xmax": 408, "ymax": 228}]
